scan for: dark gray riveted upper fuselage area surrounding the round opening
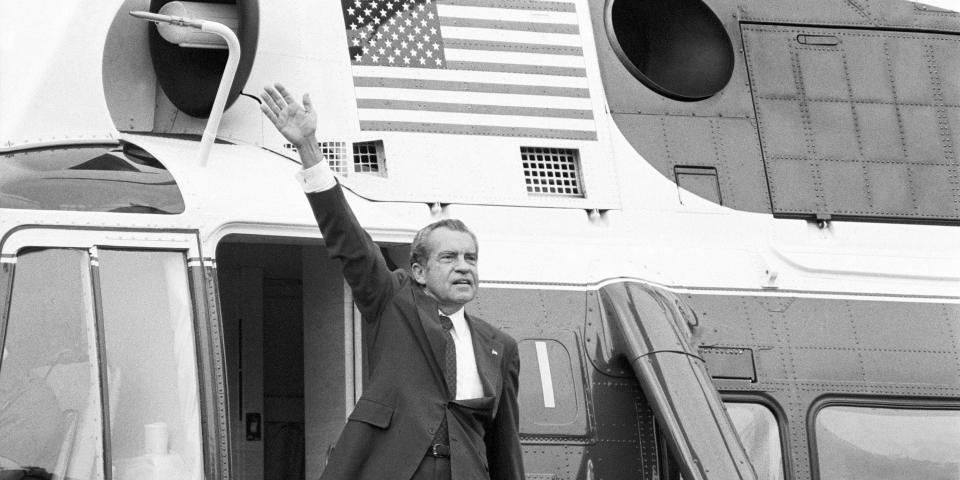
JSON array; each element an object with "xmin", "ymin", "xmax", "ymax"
[{"xmin": 590, "ymin": 0, "xmax": 960, "ymax": 223}]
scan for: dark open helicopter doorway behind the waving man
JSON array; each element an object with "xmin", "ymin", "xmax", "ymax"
[{"xmin": 217, "ymin": 236, "xmax": 357, "ymax": 480}]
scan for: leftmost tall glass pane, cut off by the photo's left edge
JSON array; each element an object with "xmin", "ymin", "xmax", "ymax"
[{"xmin": 0, "ymin": 249, "xmax": 104, "ymax": 479}]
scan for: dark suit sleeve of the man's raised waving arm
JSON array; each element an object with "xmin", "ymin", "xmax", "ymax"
[{"xmin": 307, "ymin": 183, "xmax": 399, "ymax": 320}]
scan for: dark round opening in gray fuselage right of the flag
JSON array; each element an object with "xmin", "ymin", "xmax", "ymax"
[{"xmin": 606, "ymin": 0, "xmax": 733, "ymax": 101}]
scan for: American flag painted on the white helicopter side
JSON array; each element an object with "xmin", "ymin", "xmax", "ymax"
[{"xmin": 341, "ymin": 0, "xmax": 596, "ymax": 140}]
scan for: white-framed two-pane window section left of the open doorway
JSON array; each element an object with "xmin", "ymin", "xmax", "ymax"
[{"xmin": 0, "ymin": 228, "xmax": 216, "ymax": 480}]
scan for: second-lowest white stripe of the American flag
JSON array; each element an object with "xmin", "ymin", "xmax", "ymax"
[{"xmin": 356, "ymin": 88, "xmax": 593, "ymax": 110}]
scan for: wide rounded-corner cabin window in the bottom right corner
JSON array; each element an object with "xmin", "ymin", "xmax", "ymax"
[{"xmin": 815, "ymin": 406, "xmax": 960, "ymax": 480}]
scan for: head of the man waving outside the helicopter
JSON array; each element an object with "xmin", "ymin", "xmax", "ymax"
[{"xmin": 412, "ymin": 228, "xmax": 479, "ymax": 314}]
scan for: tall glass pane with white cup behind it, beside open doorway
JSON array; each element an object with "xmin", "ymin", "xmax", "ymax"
[{"xmin": 100, "ymin": 250, "xmax": 203, "ymax": 480}]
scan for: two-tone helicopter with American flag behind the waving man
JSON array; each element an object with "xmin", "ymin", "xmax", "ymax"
[{"xmin": 0, "ymin": 0, "xmax": 960, "ymax": 480}]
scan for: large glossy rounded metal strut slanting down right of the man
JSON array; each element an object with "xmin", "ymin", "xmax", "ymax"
[{"xmin": 600, "ymin": 282, "xmax": 757, "ymax": 480}]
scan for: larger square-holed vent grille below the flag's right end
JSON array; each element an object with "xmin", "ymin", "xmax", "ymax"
[{"xmin": 520, "ymin": 147, "xmax": 584, "ymax": 197}]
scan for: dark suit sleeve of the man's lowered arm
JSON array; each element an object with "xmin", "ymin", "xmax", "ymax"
[{"xmin": 484, "ymin": 342, "xmax": 524, "ymax": 480}]
